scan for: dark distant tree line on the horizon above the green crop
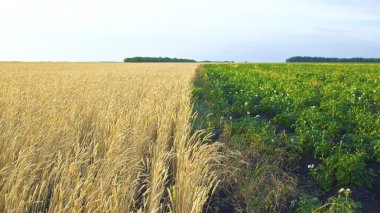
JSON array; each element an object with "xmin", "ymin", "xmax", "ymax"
[{"xmin": 286, "ymin": 56, "xmax": 380, "ymax": 63}]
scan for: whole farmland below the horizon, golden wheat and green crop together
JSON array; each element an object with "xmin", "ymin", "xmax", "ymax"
[{"xmin": 0, "ymin": 62, "xmax": 380, "ymax": 212}]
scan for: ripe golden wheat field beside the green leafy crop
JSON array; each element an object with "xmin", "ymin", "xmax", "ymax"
[{"xmin": 0, "ymin": 62, "xmax": 225, "ymax": 213}]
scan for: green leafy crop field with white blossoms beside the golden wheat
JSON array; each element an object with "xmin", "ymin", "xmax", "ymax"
[{"xmin": 194, "ymin": 64, "xmax": 380, "ymax": 212}]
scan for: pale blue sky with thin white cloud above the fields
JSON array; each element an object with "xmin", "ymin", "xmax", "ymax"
[{"xmin": 0, "ymin": 0, "xmax": 380, "ymax": 62}]
